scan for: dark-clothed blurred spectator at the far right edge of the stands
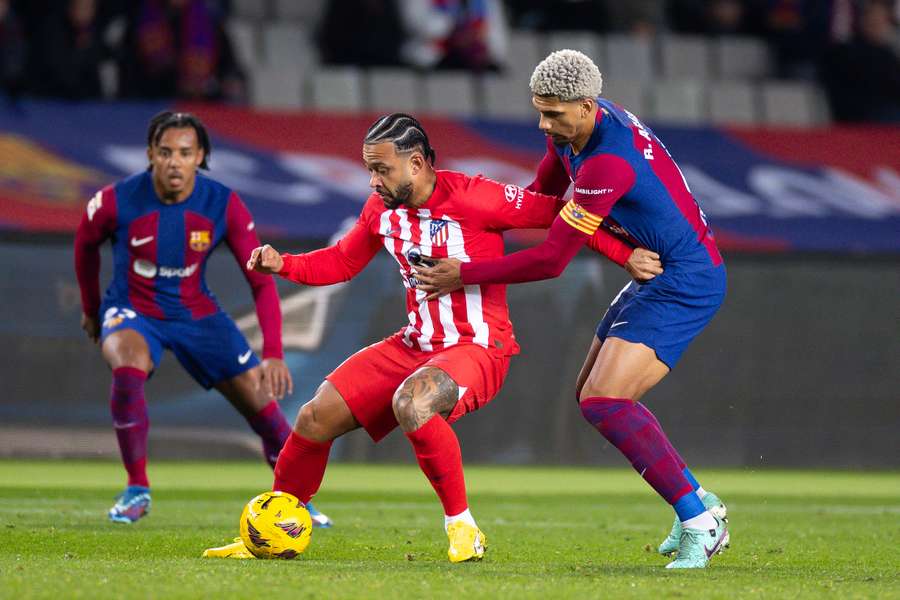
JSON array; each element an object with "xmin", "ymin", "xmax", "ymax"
[{"xmin": 822, "ymin": 0, "xmax": 900, "ymax": 123}]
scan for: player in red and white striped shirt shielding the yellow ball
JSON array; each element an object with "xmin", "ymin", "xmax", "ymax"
[{"xmin": 207, "ymin": 113, "xmax": 661, "ymax": 562}]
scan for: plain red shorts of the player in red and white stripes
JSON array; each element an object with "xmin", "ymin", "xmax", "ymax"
[{"xmin": 325, "ymin": 335, "xmax": 509, "ymax": 442}]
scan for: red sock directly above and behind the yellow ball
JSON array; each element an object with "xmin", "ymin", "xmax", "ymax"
[{"xmin": 272, "ymin": 431, "xmax": 331, "ymax": 504}]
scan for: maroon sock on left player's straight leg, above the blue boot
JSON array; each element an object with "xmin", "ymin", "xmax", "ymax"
[{"xmin": 109, "ymin": 367, "xmax": 150, "ymax": 487}]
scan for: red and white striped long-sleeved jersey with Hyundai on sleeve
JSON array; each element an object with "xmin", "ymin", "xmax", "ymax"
[{"xmin": 280, "ymin": 171, "xmax": 562, "ymax": 354}]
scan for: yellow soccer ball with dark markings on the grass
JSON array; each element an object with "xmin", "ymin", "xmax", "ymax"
[{"xmin": 241, "ymin": 492, "xmax": 312, "ymax": 558}]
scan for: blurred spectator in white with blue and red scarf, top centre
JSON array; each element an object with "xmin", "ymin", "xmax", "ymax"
[{"xmin": 399, "ymin": 0, "xmax": 508, "ymax": 71}]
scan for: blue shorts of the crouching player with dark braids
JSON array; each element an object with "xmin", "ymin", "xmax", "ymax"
[{"xmin": 100, "ymin": 302, "xmax": 259, "ymax": 389}]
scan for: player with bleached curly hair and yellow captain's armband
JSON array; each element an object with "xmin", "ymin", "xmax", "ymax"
[{"xmin": 416, "ymin": 50, "xmax": 729, "ymax": 568}]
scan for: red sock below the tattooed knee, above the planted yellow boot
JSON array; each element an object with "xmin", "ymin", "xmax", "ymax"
[{"xmin": 406, "ymin": 415, "xmax": 469, "ymax": 516}]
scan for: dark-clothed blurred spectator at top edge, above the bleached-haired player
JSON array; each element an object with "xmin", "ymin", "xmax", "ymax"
[{"xmin": 507, "ymin": 0, "xmax": 610, "ymax": 33}]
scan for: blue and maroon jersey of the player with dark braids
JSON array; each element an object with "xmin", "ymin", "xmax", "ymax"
[{"xmin": 75, "ymin": 171, "xmax": 282, "ymax": 358}]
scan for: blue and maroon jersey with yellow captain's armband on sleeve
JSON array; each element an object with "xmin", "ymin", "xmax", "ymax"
[{"xmin": 462, "ymin": 98, "xmax": 722, "ymax": 283}]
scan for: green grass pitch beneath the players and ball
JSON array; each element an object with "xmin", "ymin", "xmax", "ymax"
[{"xmin": 0, "ymin": 461, "xmax": 900, "ymax": 598}]
